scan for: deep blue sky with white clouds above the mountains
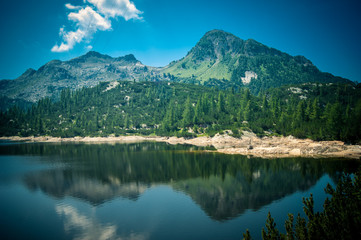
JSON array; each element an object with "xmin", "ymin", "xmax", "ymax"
[{"xmin": 0, "ymin": 0, "xmax": 361, "ymax": 82}]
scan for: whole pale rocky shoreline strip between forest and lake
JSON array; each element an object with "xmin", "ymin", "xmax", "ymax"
[{"xmin": 0, "ymin": 132, "xmax": 361, "ymax": 159}]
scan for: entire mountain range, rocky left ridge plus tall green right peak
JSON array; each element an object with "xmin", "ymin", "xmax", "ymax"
[{"xmin": 0, "ymin": 30, "xmax": 352, "ymax": 110}]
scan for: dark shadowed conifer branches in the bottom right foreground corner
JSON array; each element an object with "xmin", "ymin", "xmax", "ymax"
[{"xmin": 243, "ymin": 171, "xmax": 361, "ymax": 240}]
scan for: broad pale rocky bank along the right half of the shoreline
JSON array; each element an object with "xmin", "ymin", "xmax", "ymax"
[{"xmin": 161, "ymin": 131, "xmax": 361, "ymax": 159}]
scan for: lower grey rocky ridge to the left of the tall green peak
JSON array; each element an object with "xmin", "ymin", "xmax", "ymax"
[{"xmin": 0, "ymin": 51, "xmax": 158, "ymax": 102}]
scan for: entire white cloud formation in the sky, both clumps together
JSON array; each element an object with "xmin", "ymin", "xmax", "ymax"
[{"xmin": 51, "ymin": 0, "xmax": 142, "ymax": 52}]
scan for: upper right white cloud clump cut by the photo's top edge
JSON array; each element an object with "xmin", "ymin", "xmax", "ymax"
[{"xmin": 88, "ymin": 0, "xmax": 142, "ymax": 21}]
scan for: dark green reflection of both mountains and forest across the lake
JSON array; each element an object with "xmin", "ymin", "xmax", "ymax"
[{"xmin": 1, "ymin": 142, "xmax": 357, "ymax": 222}]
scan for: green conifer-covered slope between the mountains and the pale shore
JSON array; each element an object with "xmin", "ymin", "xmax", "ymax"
[{"xmin": 0, "ymin": 81, "xmax": 361, "ymax": 143}]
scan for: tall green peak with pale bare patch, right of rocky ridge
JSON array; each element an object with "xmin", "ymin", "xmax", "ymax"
[{"xmin": 163, "ymin": 30, "xmax": 350, "ymax": 92}]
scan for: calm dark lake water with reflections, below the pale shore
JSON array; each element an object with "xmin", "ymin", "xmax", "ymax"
[{"xmin": 0, "ymin": 142, "xmax": 360, "ymax": 240}]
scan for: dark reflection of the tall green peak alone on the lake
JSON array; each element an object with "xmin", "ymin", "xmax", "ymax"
[{"xmin": 175, "ymin": 168, "xmax": 318, "ymax": 220}]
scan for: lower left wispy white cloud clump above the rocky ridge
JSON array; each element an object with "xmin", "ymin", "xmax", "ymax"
[{"xmin": 51, "ymin": 6, "xmax": 111, "ymax": 52}]
